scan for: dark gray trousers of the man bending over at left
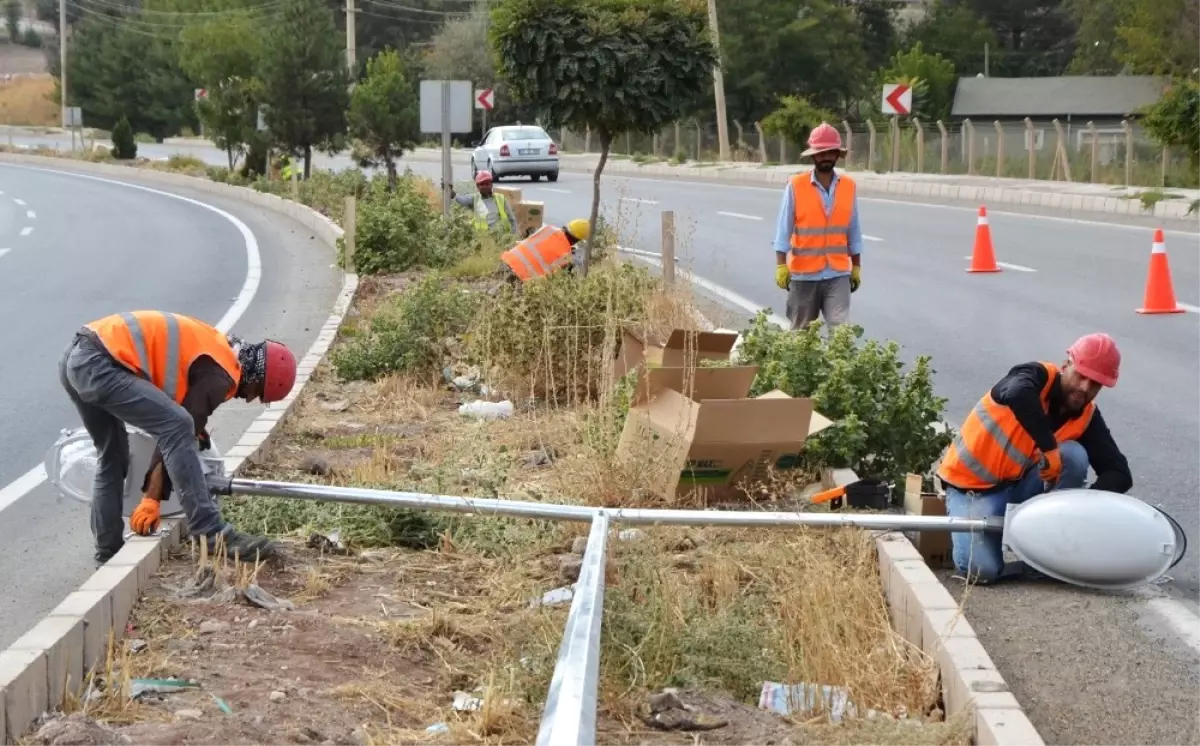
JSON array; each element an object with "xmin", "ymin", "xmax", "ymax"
[{"xmin": 59, "ymin": 335, "xmax": 224, "ymax": 552}]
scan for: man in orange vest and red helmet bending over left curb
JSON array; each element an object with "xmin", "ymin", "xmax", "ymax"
[{"xmin": 59, "ymin": 311, "xmax": 296, "ymax": 564}]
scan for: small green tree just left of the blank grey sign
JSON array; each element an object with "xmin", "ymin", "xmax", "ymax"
[{"xmin": 349, "ymin": 49, "xmax": 420, "ymax": 191}]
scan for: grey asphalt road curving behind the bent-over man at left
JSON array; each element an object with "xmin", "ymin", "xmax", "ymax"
[{"xmin": 0, "ymin": 164, "xmax": 342, "ymax": 649}]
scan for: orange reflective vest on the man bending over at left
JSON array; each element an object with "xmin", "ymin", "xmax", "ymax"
[{"xmin": 86, "ymin": 311, "xmax": 241, "ymax": 404}]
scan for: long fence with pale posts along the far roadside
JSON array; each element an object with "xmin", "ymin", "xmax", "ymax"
[{"xmin": 552, "ymin": 119, "xmax": 1200, "ymax": 187}]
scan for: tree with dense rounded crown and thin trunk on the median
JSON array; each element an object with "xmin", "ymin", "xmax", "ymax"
[{"xmin": 492, "ymin": 0, "xmax": 718, "ymax": 272}]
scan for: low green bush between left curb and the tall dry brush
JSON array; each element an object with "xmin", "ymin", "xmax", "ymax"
[{"xmin": 332, "ymin": 273, "xmax": 478, "ymax": 380}]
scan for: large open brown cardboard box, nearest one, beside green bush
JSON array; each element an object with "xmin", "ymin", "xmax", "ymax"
[{"xmin": 617, "ymin": 364, "xmax": 833, "ymax": 500}]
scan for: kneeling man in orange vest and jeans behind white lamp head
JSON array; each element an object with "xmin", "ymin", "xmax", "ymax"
[{"xmin": 937, "ymin": 333, "xmax": 1133, "ymax": 583}]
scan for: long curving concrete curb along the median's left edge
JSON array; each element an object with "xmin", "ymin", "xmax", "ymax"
[{"xmin": 0, "ymin": 154, "xmax": 359, "ymax": 746}]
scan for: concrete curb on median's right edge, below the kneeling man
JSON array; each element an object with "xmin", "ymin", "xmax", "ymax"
[{"xmin": 875, "ymin": 534, "xmax": 1045, "ymax": 746}]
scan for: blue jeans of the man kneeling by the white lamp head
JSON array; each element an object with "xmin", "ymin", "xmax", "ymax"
[{"xmin": 946, "ymin": 440, "xmax": 1088, "ymax": 583}]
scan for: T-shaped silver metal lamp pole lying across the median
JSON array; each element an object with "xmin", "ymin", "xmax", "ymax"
[{"xmin": 214, "ymin": 480, "xmax": 988, "ymax": 746}]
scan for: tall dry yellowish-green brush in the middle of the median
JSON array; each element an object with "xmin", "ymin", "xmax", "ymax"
[{"xmin": 467, "ymin": 261, "xmax": 661, "ymax": 402}]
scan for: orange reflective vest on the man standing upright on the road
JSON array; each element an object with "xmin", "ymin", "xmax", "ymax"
[{"xmin": 787, "ymin": 173, "xmax": 858, "ymax": 275}]
